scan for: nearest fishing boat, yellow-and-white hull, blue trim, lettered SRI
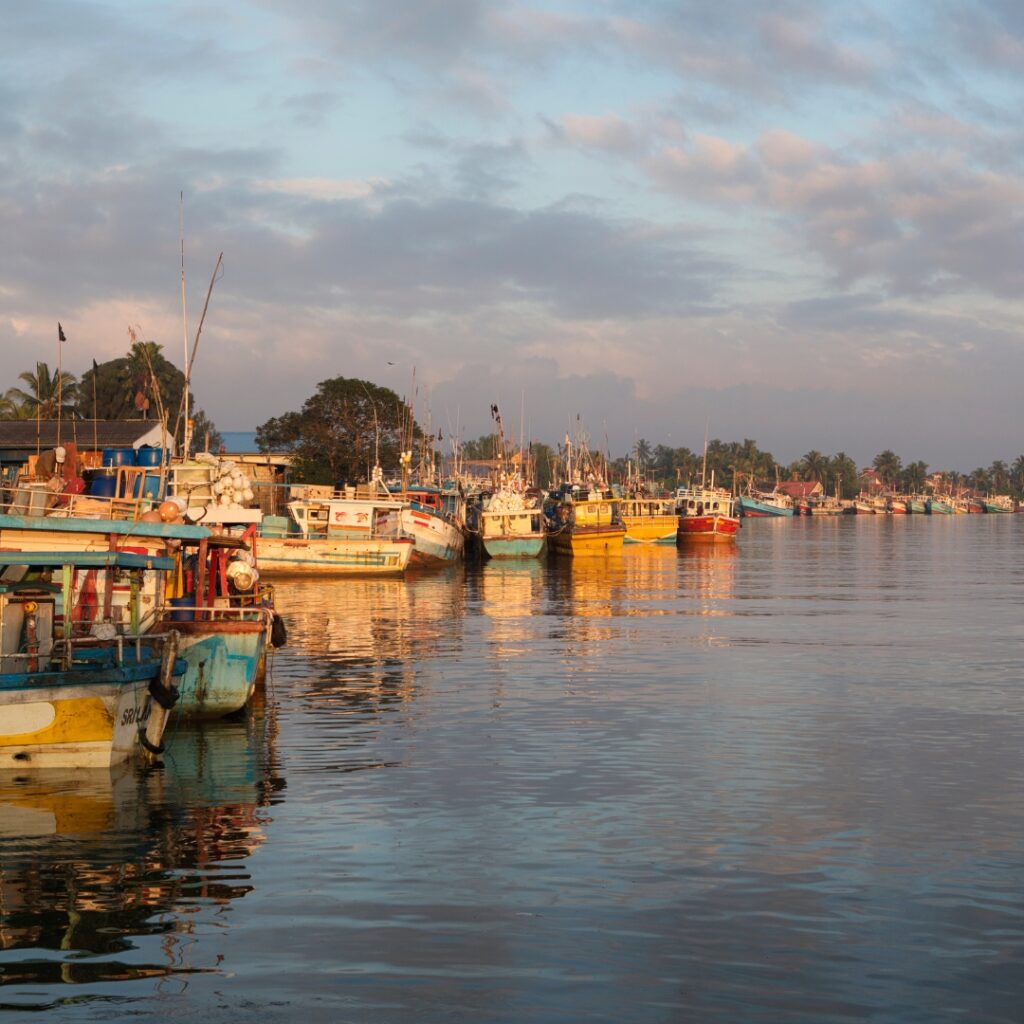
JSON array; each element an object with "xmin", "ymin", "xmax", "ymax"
[{"xmin": 0, "ymin": 550, "xmax": 184, "ymax": 769}]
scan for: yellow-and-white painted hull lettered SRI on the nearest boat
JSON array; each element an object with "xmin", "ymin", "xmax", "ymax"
[{"xmin": 0, "ymin": 662, "xmax": 160, "ymax": 769}]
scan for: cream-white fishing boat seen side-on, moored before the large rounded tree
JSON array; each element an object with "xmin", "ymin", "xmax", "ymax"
[{"xmin": 255, "ymin": 487, "xmax": 414, "ymax": 577}]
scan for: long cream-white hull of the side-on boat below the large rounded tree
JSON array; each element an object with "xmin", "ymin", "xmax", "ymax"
[{"xmin": 256, "ymin": 537, "xmax": 413, "ymax": 577}]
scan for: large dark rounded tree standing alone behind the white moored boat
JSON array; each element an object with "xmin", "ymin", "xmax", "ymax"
[{"xmin": 256, "ymin": 377, "xmax": 423, "ymax": 483}]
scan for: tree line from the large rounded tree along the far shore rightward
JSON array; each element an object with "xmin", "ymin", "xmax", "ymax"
[{"xmin": 256, "ymin": 377, "xmax": 1024, "ymax": 499}]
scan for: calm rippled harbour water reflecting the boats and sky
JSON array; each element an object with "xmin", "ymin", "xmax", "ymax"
[{"xmin": 0, "ymin": 516, "xmax": 1024, "ymax": 1024}]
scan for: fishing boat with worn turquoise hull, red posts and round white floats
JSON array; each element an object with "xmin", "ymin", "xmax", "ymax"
[{"xmin": 158, "ymin": 527, "xmax": 283, "ymax": 718}]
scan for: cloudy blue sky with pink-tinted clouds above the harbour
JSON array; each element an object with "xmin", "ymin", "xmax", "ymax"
[{"xmin": 0, "ymin": 0, "xmax": 1024, "ymax": 471}]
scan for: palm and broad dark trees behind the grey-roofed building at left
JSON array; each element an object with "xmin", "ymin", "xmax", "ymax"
[{"xmin": 0, "ymin": 340, "xmax": 221, "ymax": 447}]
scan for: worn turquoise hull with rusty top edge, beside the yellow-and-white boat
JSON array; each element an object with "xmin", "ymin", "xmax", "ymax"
[{"xmin": 158, "ymin": 621, "xmax": 266, "ymax": 718}]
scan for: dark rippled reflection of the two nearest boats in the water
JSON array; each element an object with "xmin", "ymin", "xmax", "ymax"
[{"xmin": 0, "ymin": 707, "xmax": 284, "ymax": 1011}]
